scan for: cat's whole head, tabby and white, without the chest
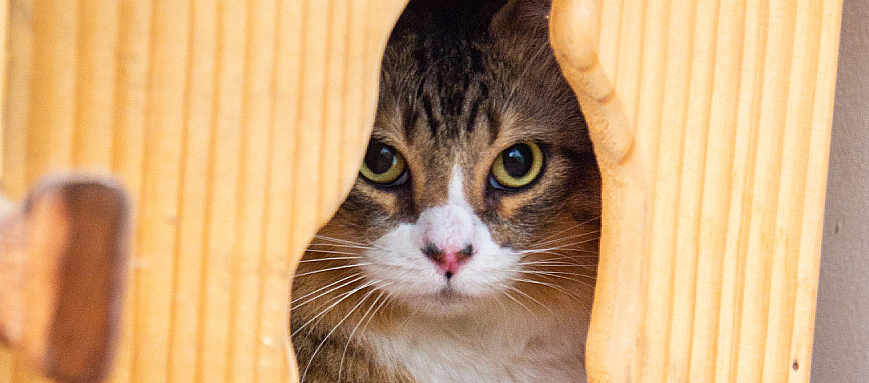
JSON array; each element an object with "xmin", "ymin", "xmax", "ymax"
[{"xmin": 295, "ymin": 1, "xmax": 600, "ymax": 315}]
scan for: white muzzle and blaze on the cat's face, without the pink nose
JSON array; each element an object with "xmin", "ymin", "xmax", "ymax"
[{"xmin": 362, "ymin": 167, "xmax": 520, "ymax": 313}]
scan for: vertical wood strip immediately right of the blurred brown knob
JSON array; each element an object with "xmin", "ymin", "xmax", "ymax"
[{"xmin": 131, "ymin": 1, "xmax": 188, "ymax": 382}]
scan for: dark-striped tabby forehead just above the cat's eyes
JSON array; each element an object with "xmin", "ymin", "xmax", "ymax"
[{"xmin": 375, "ymin": 22, "xmax": 584, "ymax": 147}]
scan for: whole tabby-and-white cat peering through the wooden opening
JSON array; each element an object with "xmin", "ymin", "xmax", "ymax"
[{"xmin": 290, "ymin": 0, "xmax": 601, "ymax": 383}]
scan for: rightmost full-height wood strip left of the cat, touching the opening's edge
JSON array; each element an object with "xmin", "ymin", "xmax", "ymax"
[{"xmin": 257, "ymin": 0, "xmax": 305, "ymax": 382}]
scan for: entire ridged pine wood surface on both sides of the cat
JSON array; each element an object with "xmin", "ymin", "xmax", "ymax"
[{"xmin": 0, "ymin": 0, "xmax": 841, "ymax": 383}]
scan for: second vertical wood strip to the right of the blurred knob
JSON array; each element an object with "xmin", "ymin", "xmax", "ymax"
[{"xmin": 167, "ymin": 0, "xmax": 217, "ymax": 382}]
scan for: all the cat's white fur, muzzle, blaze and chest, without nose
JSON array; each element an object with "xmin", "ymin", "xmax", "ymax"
[{"xmin": 363, "ymin": 166, "xmax": 588, "ymax": 383}]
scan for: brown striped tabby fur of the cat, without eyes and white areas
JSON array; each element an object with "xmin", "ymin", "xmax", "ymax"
[{"xmin": 291, "ymin": 0, "xmax": 600, "ymax": 383}]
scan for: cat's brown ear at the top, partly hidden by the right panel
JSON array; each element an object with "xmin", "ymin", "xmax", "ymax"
[{"xmin": 489, "ymin": 0, "xmax": 552, "ymax": 41}]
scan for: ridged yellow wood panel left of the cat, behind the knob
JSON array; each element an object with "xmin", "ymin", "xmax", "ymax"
[{"xmin": 0, "ymin": 0, "xmax": 405, "ymax": 383}]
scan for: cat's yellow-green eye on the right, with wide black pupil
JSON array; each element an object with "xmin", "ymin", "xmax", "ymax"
[{"xmin": 489, "ymin": 141, "xmax": 543, "ymax": 189}]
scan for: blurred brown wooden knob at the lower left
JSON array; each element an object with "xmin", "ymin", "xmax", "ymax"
[{"xmin": 0, "ymin": 176, "xmax": 129, "ymax": 382}]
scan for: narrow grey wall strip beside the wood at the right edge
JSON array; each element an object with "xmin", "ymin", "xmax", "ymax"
[{"xmin": 812, "ymin": 0, "xmax": 869, "ymax": 383}]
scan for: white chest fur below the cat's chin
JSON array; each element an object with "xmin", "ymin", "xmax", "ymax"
[{"xmin": 366, "ymin": 308, "xmax": 587, "ymax": 383}]
